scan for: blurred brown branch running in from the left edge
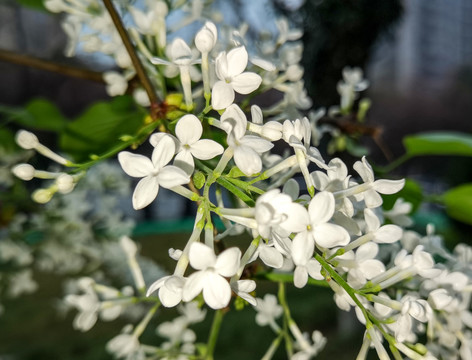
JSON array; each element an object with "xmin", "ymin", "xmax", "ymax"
[{"xmin": 0, "ymin": 49, "xmax": 104, "ymax": 83}]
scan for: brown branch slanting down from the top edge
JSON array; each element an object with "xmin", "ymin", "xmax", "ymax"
[{"xmin": 103, "ymin": 0, "xmax": 162, "ymax": 120}]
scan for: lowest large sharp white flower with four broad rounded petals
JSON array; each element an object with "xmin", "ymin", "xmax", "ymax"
[{"xmin": 182, "ymin": 243, "xmax": 241, "ymax": 309}]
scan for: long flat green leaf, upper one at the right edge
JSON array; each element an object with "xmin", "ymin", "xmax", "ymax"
[{"xmin": 403, "ymin": 132, "xmax": 472, "ymax": 156}]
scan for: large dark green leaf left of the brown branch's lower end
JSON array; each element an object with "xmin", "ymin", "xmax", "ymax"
[{"xmin": 60, "ymin": 96, "xmax": 144, "ymax": 161}]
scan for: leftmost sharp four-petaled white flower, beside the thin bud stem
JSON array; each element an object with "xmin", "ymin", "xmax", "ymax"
[{"xmin": 118, "ymin": 137, "xmax": 190, "ymax": 210}]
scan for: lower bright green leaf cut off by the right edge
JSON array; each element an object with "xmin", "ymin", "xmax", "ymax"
[{"xmin": 442, "ymin": 183, "xmax": 472, "ymax": 225}]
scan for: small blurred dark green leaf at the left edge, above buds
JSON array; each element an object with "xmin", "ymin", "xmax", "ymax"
[{"xmin": 0, "ymin": 99, "xmax": 67, "ymax": 132}]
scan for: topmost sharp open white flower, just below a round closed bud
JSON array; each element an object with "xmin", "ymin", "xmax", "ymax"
[{"xmin": 211, "ymin": 46, "xmax": 262, "ymax": 110}]
